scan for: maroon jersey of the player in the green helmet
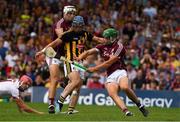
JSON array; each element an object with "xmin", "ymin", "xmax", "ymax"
[{"xmin": 96, "ymin": 41, "xmax": 126, "ymax": 76}]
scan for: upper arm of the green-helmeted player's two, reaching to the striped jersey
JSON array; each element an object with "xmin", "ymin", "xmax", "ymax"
[{"xmin": 77, "ymin": 48, "xmax": 99, "ymax": 61}]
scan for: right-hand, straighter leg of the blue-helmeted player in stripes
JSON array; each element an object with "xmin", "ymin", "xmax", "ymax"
[{"xmin": 68, "ymin": 82, "xmax": 82, "ymax": 114}]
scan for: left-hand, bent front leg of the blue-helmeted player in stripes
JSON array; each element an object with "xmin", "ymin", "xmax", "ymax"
[{"xmin": 58, "ymin": 71, "xmax": 82, "ymax": 111}]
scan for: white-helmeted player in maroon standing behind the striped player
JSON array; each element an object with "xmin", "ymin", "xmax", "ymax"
[{"xmin": 36, "ymin": 6, "xmax": 77, "ymax": 113}]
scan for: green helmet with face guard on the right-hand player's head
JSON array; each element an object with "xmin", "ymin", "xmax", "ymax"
[{"xmin": 103, "ymin": 28, "xmax": 118, "ymax": 43}]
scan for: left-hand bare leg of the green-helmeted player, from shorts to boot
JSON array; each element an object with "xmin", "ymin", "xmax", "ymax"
[{"xmin": 105, "ymin": 82, "xmax": 133, "ymax": 116}]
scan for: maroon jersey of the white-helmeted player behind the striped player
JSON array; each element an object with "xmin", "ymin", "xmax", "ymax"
[{"xmin": 52, "ymin": 18, "xmax": 72, "ymax": 57}]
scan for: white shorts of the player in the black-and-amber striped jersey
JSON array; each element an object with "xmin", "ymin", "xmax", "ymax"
[{"xmin": 64, "ymin": 62, "xmax": 85, "ymax": 79}]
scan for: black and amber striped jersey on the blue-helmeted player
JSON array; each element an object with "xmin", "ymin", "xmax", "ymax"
[{"xmin": 61, "ymin": 30, "xmax": 93, "ymax": 60}]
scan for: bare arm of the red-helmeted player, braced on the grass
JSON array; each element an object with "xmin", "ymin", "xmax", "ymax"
[{"xmin": 13, "ymin": 98, "xmax": 43, "ymax": 114}]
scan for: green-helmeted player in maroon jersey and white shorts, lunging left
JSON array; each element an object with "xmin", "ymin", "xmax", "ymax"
[{"xmin": 77, "ymin": 28, "xmax": 148, "ymax": 117}]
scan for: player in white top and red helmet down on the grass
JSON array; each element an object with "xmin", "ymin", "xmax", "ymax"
[{"xmin": 0, "ymin": 75, "xmax": 43, "ymax": 114}]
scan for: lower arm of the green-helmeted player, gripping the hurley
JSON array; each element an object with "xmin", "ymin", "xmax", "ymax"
[{"xmin": 88, "ymin": 55, "xmax": 119, "ymax": 72}]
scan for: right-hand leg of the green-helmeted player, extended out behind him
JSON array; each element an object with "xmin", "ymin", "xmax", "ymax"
[{"xmin": 119, "ymin": 76, "xmax": 148, "ymax": 117}]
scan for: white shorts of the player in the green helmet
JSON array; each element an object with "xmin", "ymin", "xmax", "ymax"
[{"xmin": 106, "ymin": 70, "xmax": 127, "ymax": 84}]
